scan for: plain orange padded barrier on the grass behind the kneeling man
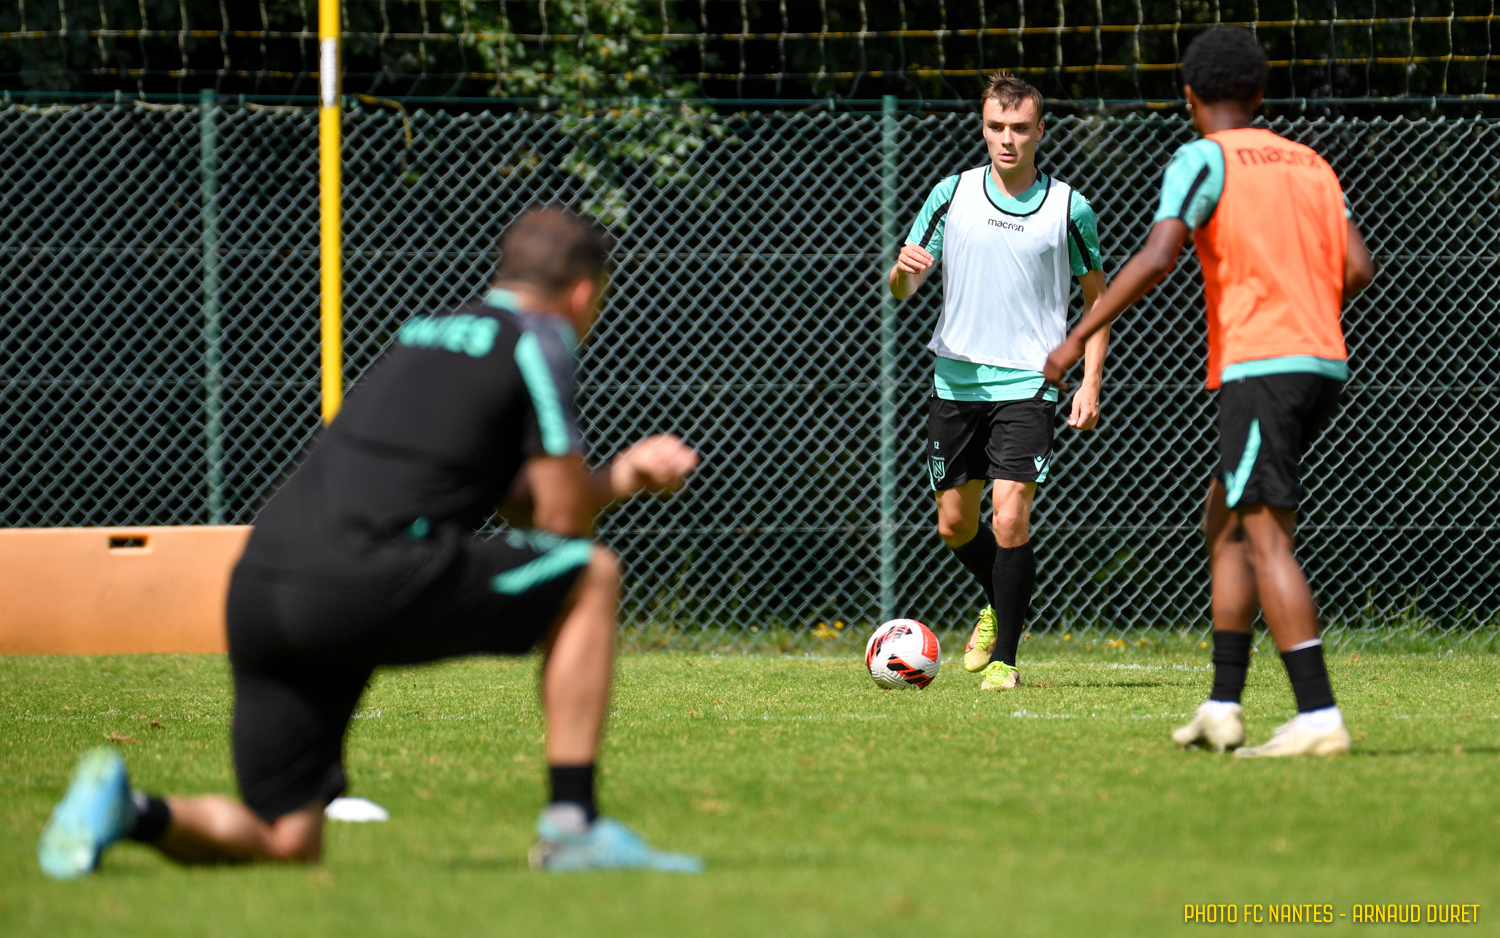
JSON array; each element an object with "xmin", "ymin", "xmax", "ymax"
[{"xmin": 0, "ymin": 525, "xmax": 251, "ymax": 654}]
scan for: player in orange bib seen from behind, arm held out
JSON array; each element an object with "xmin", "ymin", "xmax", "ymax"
[{"xmin": 1047, "ymin": 27, "xmax": 1374, "ymax": 756}]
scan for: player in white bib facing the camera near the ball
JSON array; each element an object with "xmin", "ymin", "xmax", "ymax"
[{"xmin": 888, "ymin": 74, "xmax": 1109, "ymax": 690}]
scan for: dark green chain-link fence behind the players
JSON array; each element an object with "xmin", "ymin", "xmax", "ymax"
[{"xmin": 0, "ymin": 102, "xmax": 1500, "ymax": 648}]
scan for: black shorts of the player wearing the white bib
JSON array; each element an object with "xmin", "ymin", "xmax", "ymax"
[{"xmin": 927, "ymin": 396, "xmax": 1058, "ymax": 492}]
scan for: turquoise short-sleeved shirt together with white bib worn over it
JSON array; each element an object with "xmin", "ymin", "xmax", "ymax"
[{"xmin": 906, "ymin": 164, "xmax": 1100, "ymax": 401}]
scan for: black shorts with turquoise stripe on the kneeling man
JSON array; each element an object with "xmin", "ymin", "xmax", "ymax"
[{"xmin": 228, "ymin": 531, "xmax": 593, "ymax": 822}]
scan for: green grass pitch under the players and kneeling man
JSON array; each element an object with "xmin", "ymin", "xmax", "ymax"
[{"xmin": 0, "ymin": 644, "xmax": 1500, "ymax": 938}]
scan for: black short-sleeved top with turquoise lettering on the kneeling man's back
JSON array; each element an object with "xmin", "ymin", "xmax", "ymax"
[{"xmin": 240, "ymin": 290, "xmax": 584, "ymax": 582}]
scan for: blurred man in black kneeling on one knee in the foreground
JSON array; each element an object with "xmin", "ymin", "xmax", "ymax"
[{"xmin": 38, "ymin": 207, "xmax": 701, "ymax": 878}]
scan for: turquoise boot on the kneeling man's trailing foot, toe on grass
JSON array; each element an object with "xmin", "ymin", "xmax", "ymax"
[{"xmin": 36, "ymin": 749, "xmax": 135, "ymax": 879}]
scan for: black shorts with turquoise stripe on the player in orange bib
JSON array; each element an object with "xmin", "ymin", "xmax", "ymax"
[{"xmin": 1218, "ymin": 374, "xmax": 1344, "ymax": 509}]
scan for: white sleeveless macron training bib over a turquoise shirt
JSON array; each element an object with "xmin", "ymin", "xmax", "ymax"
[{"xmin": 927, "ymin": 165, "xmax": 1073, "ymax": 371}]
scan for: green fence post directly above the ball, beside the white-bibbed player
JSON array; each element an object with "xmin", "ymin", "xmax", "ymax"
[{"xmin": 879, "ymin": 95, "xmax": 899, "ymax": 621}]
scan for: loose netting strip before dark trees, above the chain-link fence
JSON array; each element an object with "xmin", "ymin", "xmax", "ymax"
[{"xmin": 0, "ymin": 0, "xmax": 1500, "ymax": 107}]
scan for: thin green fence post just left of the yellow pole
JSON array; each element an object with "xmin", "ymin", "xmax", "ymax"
[{"xmin": 198, "ymin": 89, "xmax": 224, "ymax": 524}]
